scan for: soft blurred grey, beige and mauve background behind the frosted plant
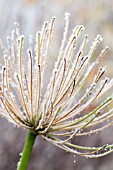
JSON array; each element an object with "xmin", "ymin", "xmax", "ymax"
[{"xmin": 0, "ymin": 0, "xmax": 113, "ymax": 170}]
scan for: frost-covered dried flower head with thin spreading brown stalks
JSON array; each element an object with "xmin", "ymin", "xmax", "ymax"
[{"xmin": 0, "ymin": 13, "xmax": 113, "ymax": 158}]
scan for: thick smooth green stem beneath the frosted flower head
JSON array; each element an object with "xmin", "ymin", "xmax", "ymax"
[{"xmin": 18, "ymin": 131, "xmax": 36, "ymax": 170}]
